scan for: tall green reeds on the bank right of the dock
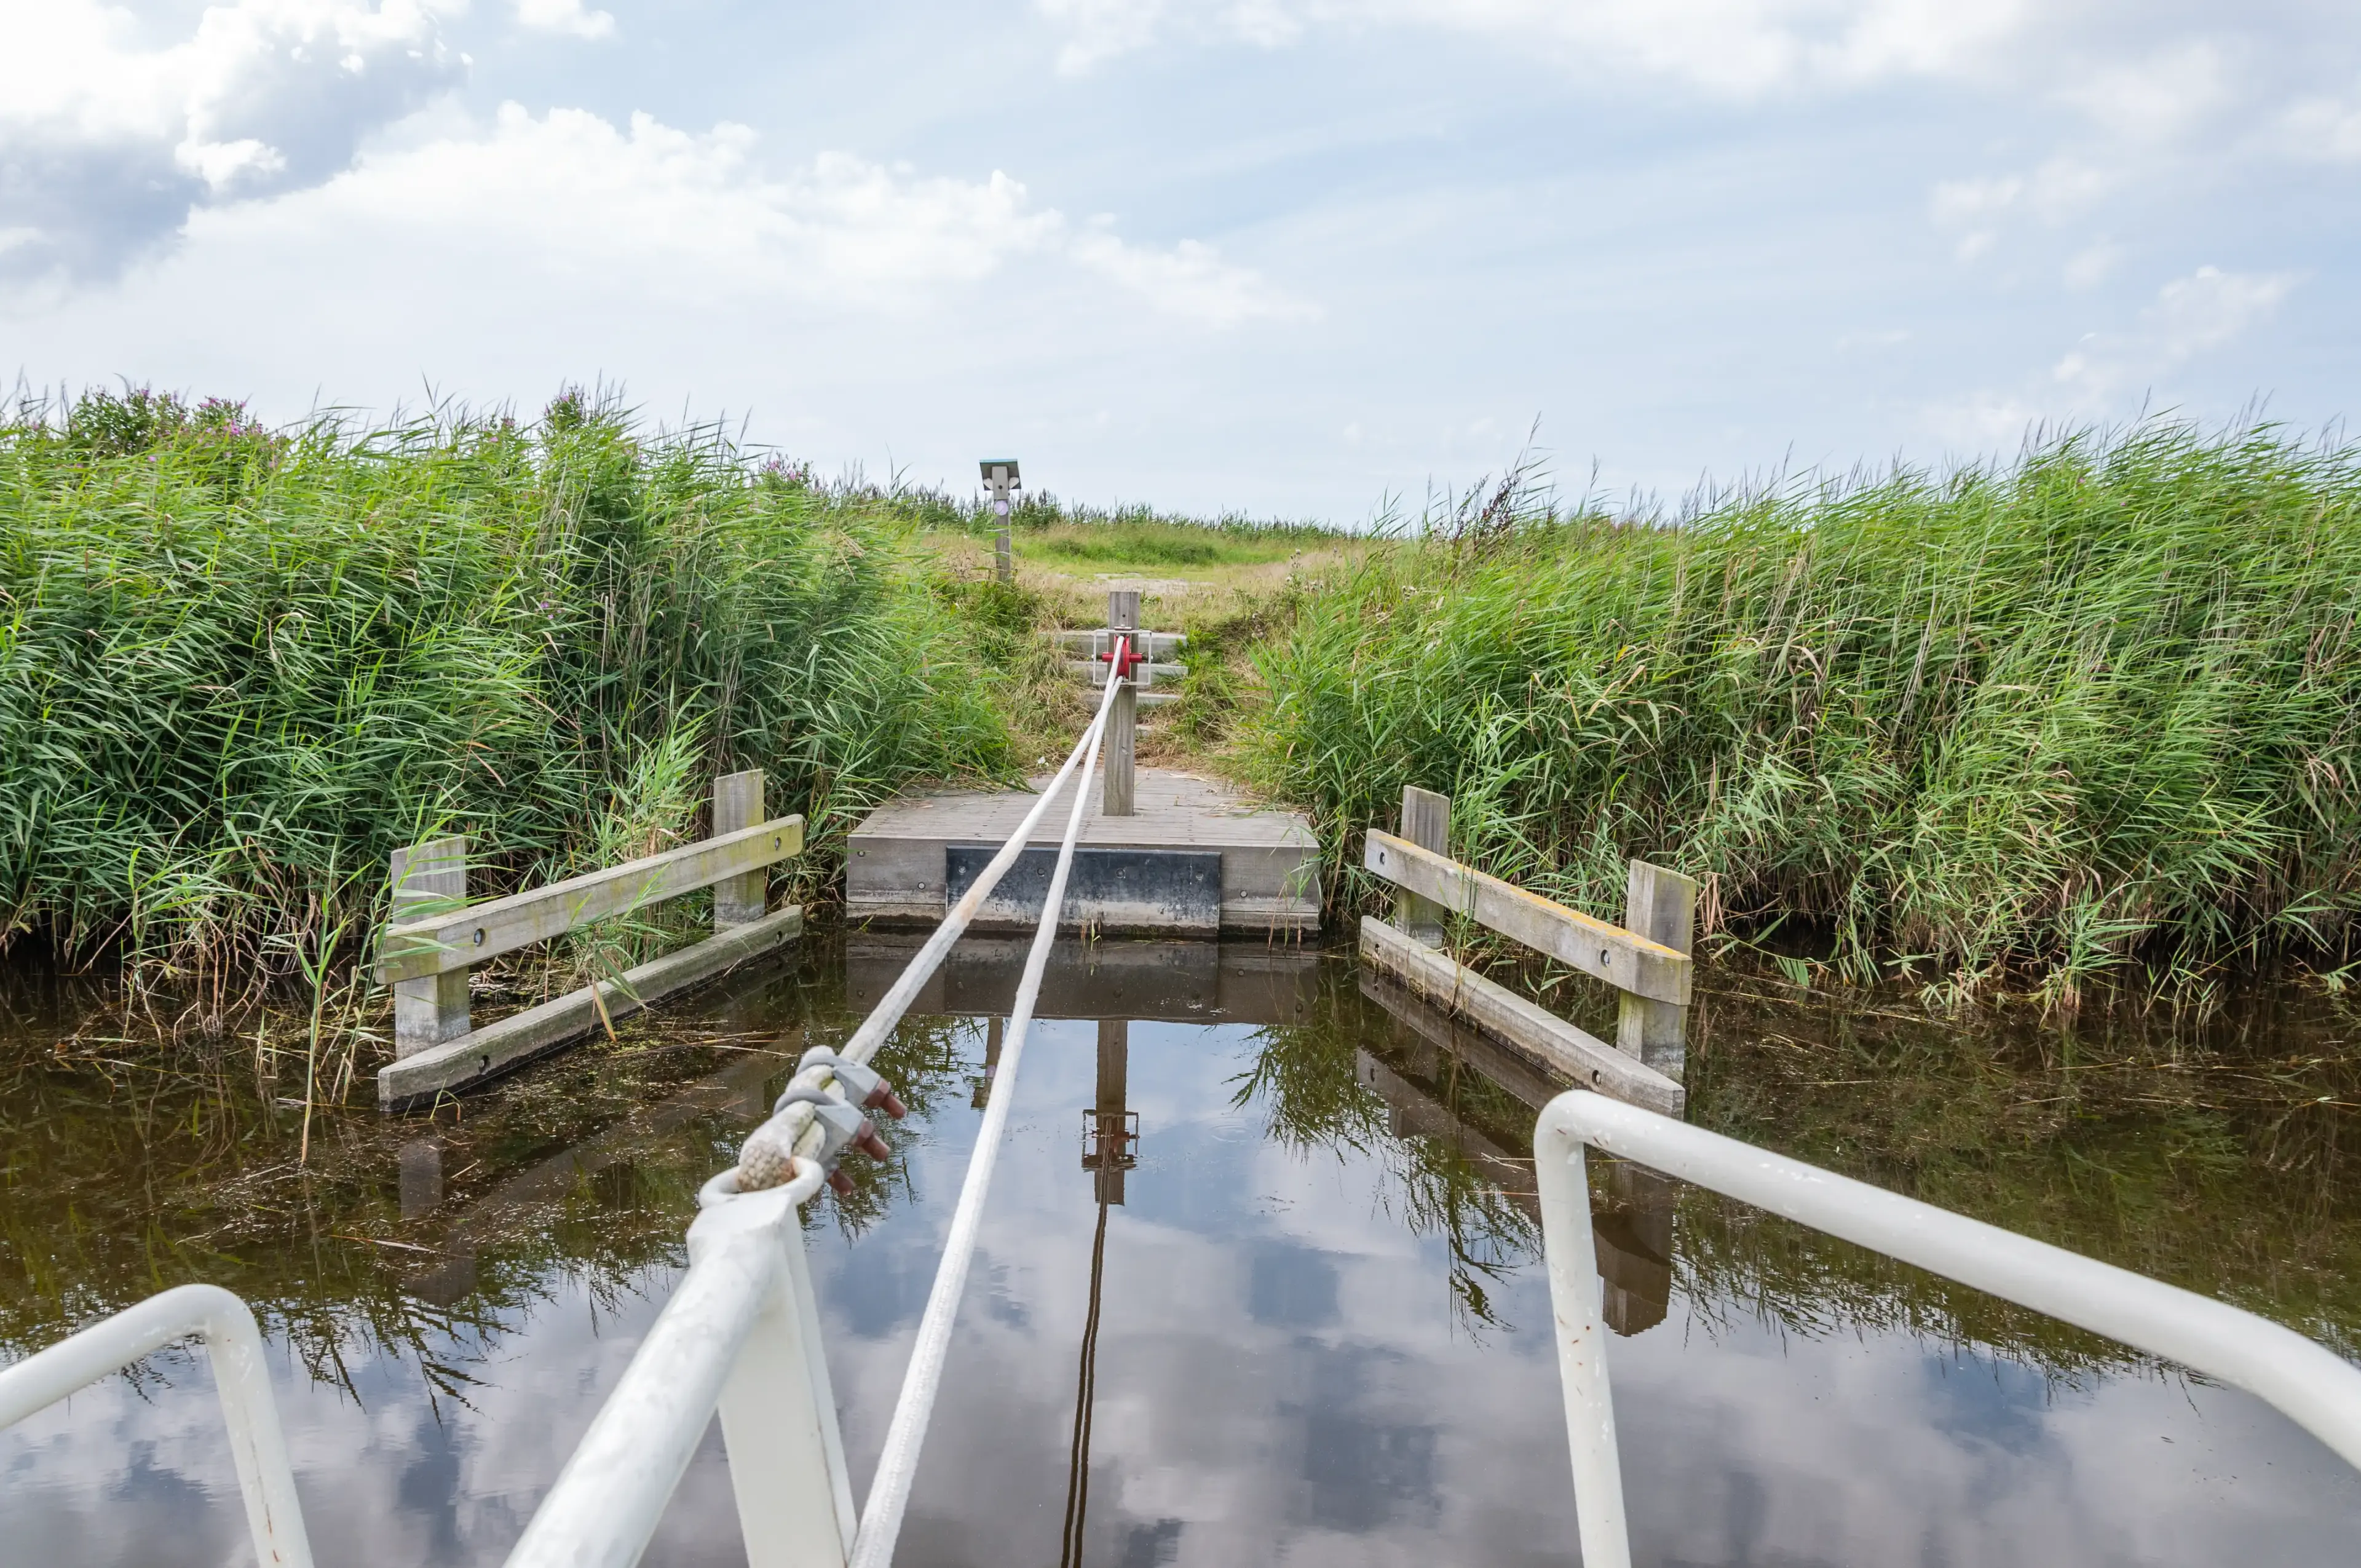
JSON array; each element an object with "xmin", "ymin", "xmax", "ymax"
[{"xmin": 1242, "ymin": 422, "xmax": 2361, "ymax": 997}]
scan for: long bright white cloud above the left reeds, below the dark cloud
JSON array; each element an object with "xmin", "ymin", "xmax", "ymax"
[{"xmin": 208, "ymin": 104, "xmax": 1306, "ymax": 326}]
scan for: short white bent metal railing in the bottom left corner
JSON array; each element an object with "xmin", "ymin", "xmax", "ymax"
[{"xmin": 0, "ymin": 1285, "xmax": 312, "ymax": 1568}]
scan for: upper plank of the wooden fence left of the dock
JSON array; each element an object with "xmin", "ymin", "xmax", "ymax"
[{"xmin": 378, "ymin": 817, "xmax": 803, "ymax": 984}]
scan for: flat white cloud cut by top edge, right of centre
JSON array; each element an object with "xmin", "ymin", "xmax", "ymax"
[{"xmin": 1037, "ymin": 0, "xmax": 2033, "ymax": 97}]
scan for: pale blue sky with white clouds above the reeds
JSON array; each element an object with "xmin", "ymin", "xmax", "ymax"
[{"xmin": 0, "ymin": 0, "xmax": 2361, "ymax": 525}]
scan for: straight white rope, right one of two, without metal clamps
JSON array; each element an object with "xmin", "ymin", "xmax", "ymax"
[{"xmin": 850, "ymin": 640, "xmax": 1124, "ymax": 1568}]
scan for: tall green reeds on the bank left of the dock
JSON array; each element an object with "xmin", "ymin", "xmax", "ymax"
[{"xmin": 0, "ymin": 392, "xmax": 1008, "ymax": 984}]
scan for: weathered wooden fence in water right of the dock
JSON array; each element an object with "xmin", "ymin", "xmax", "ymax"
[{"xmin": 1360, "ymin": 789, "xmax": 1698, "ymax": 1115}]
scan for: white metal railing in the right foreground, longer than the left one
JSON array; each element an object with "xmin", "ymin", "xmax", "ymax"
[{"xmin": 1532, "ymin": 1088, "xmax": 2361, "ymax": 1568}]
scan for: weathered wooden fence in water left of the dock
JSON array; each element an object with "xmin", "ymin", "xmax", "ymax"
[{"xmin": 378, "ymin": 767, "xmax": 803, "ymax": 1110}]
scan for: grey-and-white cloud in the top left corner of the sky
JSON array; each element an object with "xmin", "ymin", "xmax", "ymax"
[{"xmin": 0, "ymin": 0, "xmax": 463, "ymax": 281}]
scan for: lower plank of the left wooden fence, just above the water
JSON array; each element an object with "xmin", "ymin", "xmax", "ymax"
[{"xmin": 378, "ymin": 905, "xmax": 803, "ymax": 1110}]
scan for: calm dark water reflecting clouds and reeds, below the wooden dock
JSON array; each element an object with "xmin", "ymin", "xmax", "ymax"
[{"xmin": 0, "ymin": 938, "xmax": 2361, "ymax": 1568}]
